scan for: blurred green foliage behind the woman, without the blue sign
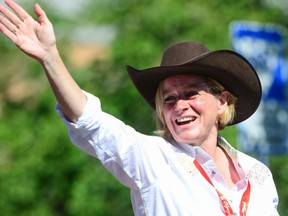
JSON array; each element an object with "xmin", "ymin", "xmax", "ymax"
[{"xmin": 0, "ymin": 0, "xmax": 288, "ymax": 216}]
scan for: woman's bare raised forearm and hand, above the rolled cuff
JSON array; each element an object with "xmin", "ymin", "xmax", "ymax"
[{"xmin": 0, "ymin": 0, "xmax": 86, "ymax": 122}]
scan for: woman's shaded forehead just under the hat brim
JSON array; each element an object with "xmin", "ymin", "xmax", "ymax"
[{"xmin": 163, "ymin": 74, "xmax": 205, "ymax": 91}]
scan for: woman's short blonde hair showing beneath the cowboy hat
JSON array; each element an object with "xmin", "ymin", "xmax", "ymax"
[{"xmin": 155, "ymin": 78, "xmax": 237, "ymax": 138}]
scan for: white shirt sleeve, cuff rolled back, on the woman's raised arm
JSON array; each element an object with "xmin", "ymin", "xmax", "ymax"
[{"xmin": 56, "ymin": 92, "xmax": 168, "ymax": 188}]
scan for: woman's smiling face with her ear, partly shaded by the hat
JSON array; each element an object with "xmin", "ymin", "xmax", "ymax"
[{"xmin": 163, "ymin": 75, "xmax": 229, "ymax": 146}]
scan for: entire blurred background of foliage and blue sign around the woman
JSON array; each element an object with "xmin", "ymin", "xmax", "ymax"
[{"xmin": 0, "ymin": 0, "xmax": 288, "ymax": 216}]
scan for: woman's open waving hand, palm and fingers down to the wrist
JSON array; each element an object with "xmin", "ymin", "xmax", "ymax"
[{"xmin": 0, "ymin": 0, "xmax": 56, "ymax": 61}]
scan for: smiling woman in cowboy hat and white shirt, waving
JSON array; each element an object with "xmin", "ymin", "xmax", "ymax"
[{"xmin": 0, "ymin": 0, "xmax": 278, "ymax": 216}]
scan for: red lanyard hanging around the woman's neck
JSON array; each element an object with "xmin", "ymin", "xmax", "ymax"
[{"xmin": 194, "ymin": 160, "xmax": 251, "ymax": 216}]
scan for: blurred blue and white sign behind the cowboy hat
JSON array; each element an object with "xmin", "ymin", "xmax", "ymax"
[{"xmin": 230, "ymin": 21, "xmax": 288, "ymax": 155}]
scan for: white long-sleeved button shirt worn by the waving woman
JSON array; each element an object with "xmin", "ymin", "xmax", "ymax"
[{"xmin": 56, "ymin": 93, "xmax": 278, "ymax": 216}]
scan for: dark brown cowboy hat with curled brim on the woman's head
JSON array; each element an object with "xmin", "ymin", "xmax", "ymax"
[{"xmin": 127, "ymin": 42, "xmax": 262, "ymax": 125}]
